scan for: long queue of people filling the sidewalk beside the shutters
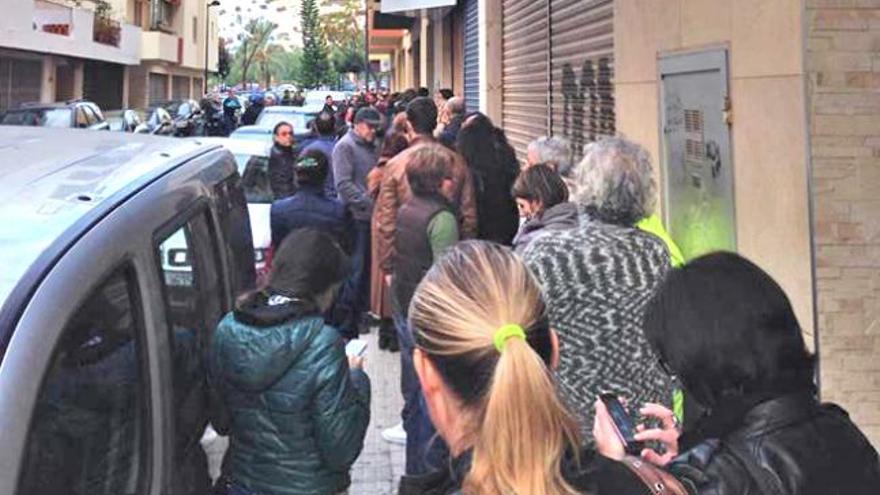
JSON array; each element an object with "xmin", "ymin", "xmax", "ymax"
[{"xmin": 210, "ymin": 88, "xmax": 880, "ymax": 495}]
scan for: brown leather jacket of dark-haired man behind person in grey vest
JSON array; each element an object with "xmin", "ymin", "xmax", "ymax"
[{"xmin": 373, "ymin": 136, "xmax": 477, "ymax": 274}]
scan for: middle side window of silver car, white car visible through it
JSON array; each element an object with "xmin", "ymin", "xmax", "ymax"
[{"xmin": 157, "ymin": 212, "xmax": 226, "ymax": 493}]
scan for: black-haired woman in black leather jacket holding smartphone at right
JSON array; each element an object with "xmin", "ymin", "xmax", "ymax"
[{"xmin": 594, "ymin": 253, "xmax": 880, "ymax": 495}]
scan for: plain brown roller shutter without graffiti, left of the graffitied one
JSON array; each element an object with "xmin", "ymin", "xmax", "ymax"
[{"xmin": 501, "ymin": 0, "xmax": 550, "ymax": 159}]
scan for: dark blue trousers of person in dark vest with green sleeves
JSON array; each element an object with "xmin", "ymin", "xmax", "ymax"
[{"xmin": 392, "ymin": 302, "xmax": 449, "ymax": 476}]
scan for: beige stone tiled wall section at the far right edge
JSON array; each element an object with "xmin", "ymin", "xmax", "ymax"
[{"xmin": 805, "ymin": 0, "xmax": 880, "ymax": 446}]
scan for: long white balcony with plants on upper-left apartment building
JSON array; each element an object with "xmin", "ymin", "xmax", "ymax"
[{"xmin": 0, "ymin": 0, "xmax": 141, "ymax": 65}]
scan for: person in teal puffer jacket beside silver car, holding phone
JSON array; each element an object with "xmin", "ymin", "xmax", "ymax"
[{"xmin": 209, "ymin": 229, "xmax": 370, "ymax": 495}]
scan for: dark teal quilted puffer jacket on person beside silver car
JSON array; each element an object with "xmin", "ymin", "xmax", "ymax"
[{"xmin": 210, "ymin": 304, "xmax": 370, "ymax": 495}]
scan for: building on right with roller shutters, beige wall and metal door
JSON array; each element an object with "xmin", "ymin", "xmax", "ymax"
[{"xmin": 371, "ymin": 0, "xmax": 880, "ymax": 445}]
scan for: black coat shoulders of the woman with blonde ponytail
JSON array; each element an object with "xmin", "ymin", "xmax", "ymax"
[{"xmin": 398, "ymin": 451, "xmax": 651, "ymax": 495}]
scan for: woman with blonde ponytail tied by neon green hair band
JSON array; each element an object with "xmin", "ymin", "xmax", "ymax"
[{"xmin": 400, "ymin": 241, "xmax": 650, "ymax": 495}]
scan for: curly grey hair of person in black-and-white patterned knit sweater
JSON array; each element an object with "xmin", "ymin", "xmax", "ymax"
[{"xmin": 573, "ymin": 137, "xmax": 657, "ymax": 226}]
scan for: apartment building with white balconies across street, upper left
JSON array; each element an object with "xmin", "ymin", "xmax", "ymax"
[{"xmin": 0, "ymin": 0, "xmax": 218, "ymax": 110}]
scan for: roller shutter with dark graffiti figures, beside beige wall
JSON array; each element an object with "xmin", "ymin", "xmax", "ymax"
[{"xmin": 550, "ymin": 0, "xmax": 615, "ymax": 159}]
